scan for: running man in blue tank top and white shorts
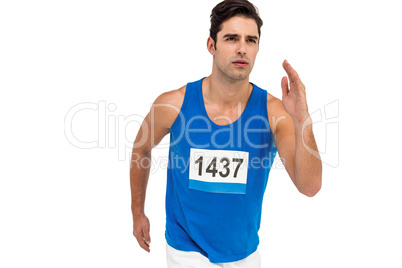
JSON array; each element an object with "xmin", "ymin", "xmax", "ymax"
[{"xmin": 130, "ymin": 0, "xmax": 322, "ymax": 268}]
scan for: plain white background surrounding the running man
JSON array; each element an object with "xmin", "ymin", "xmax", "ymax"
[{"xmin": 0, "ymin": 0, "xmax": 402, "ymax": 268}]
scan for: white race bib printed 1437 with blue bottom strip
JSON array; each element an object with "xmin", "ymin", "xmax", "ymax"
[{"xmin": 189, "ymin": 148, "xmax": 248, "ymax": 194}]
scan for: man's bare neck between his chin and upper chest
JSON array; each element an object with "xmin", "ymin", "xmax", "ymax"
[{"xmin": 202, "ymin": 72, "xmax": 252, "ymax": 109}]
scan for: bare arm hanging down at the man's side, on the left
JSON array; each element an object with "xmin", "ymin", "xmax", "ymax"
[{"xmin": 130, "ymin": 87, "xmax": 182, "ymax": 252}]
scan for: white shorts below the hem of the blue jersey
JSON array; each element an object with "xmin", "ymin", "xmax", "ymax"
[{"xmin": 166, "ymin": 243, "xmax": 261, "ymax": 268}]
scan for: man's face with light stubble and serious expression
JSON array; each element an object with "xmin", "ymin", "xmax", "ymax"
[{"xmin": 211, "ymin": 16, "xmax": 259, "ymax": 80}]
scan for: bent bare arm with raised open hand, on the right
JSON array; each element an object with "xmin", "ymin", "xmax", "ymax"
[{"xmin": 273, "ymin": 61, "xmax": 322, "ymax": 197}]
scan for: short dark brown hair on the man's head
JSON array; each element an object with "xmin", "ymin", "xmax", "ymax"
[{"xmin": 209, "ymin": 0, "xmax": 262, "ymax": 49}]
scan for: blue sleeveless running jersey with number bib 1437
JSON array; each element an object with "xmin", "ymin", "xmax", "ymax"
[{"xmin": 165, "ymin": 76, "xmax": 277, "ymax": 263}]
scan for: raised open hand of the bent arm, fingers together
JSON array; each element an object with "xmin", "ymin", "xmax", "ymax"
[{"xmin": 281, "ymin": 60, "xmax": 309, "ymax": 123}]
